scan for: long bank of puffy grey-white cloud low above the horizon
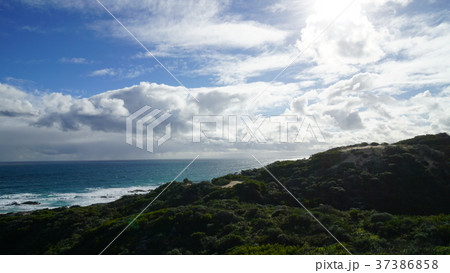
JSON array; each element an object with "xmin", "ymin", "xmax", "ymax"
[{"xmin": 0, "ymin": 74, "xmax": 450, "ymax": 159}]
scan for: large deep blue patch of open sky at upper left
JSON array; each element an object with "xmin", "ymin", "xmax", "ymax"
[{"xmin": 0, "ymin": 3, "xmax": 185, "ymax": 94}]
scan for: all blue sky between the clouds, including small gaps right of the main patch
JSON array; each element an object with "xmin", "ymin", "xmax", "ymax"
[{"xmin": 0, "ymin": 1, "xmax": 302, "ymax": 93}]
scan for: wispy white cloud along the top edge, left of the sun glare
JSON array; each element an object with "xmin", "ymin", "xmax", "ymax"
[{"xmin": 81, "ymin": 0, "xmax": 288, "ymax": 52}]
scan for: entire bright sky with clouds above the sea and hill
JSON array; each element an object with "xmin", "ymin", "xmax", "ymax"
[{"xmin": 0, "ymin": 0, "xmax": 450, "ymax": 161}]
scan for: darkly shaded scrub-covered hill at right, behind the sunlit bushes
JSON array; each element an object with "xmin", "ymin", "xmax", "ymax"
[{"xmin": 249, "ymin": 134, "xmax": 450, "ymax": 215}]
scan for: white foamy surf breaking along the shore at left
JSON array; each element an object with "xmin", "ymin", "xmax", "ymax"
[{"xmin": 0, "ymin": 186, "xmax": 157, "ymax": 213}]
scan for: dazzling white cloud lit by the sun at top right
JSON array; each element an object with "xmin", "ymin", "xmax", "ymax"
[{"xmin": 297, "ymin": 1, "xmax": 385, "ymax": 75}]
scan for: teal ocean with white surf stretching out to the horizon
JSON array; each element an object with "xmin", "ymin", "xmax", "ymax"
[{"xmin": 0, "ymin": 159, "xmax": 268, "ymax": 213}]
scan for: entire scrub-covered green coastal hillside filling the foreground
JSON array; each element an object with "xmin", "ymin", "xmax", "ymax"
[{"xmin": 0, "ymin": 133, "xmax": 450, "ymax": 254}]
